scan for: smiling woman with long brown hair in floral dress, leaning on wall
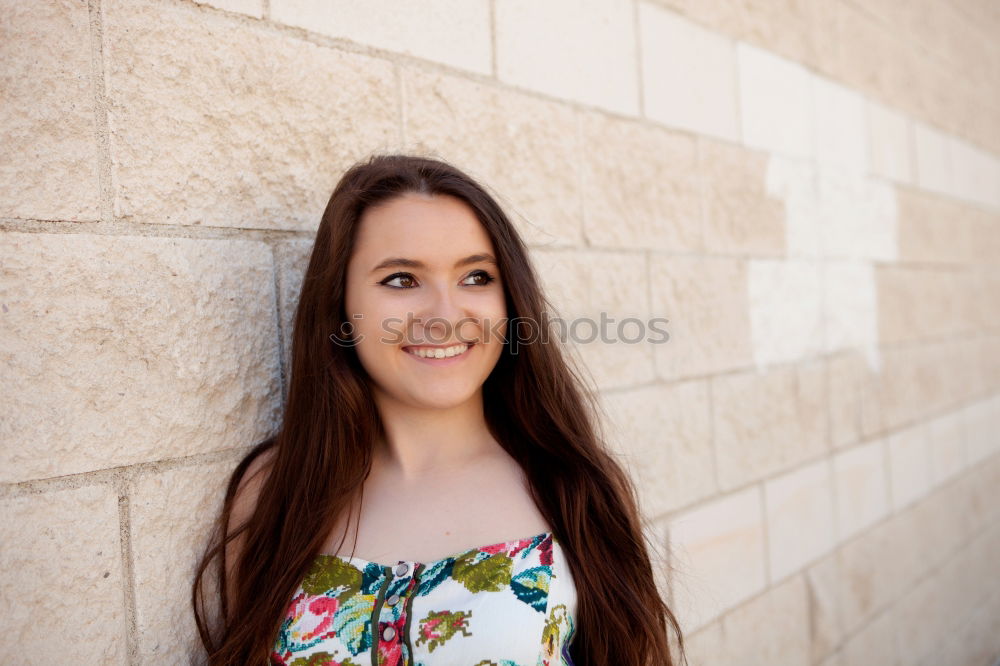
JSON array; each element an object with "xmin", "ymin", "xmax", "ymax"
[{"xmin": 193, "ymin": 155, "xmax": 683, "ymax": 666}]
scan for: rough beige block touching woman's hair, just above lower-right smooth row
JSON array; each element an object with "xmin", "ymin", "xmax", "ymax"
[{"xmin": 602, "ymin": 380, "xmax": 715, "ymax": 516}]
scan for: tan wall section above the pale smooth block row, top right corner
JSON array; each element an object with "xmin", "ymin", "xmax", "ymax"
[{"xmin": 655, "ymin": 0, "xmax": 1000, "ymax": 152}]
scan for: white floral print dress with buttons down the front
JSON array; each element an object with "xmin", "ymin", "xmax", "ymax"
[{"xmin": 271, "ymin": 532, "xmax": 576, "ymax": 666}]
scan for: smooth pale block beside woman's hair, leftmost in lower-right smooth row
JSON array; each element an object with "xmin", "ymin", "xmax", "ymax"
[{"xmin": 670, "ymin": 486, "xmax": 766, "ymax": 631}]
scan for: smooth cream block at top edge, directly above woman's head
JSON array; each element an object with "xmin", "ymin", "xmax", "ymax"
[{"xmin": 270, "ymin": 0, "xmax": 493, "ymax": 74}]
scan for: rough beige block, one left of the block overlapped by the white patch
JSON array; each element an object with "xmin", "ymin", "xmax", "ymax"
[{"xmin": 580, "ymin": 112, "xmax": 702, "ymax": 252}]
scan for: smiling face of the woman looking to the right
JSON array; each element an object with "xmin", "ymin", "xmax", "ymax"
[{"xmin": 345, "ymin": 193, "xmax": 507, "ymax": 409}]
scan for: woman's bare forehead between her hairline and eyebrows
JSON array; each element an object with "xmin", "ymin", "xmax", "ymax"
[{"xmin": 352, "ymin": 193, "xmax": 493, "ymax": 267}]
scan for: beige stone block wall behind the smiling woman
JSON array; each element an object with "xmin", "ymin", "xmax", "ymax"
[{"xmin": 0, "ymin": 0, "xmax": 1000, "ymax": 666}]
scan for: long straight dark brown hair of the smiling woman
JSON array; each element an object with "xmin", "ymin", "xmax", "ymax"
[{"xmin": 192, "ymin": 155, "xmax": 684, "ymax": 666}]
